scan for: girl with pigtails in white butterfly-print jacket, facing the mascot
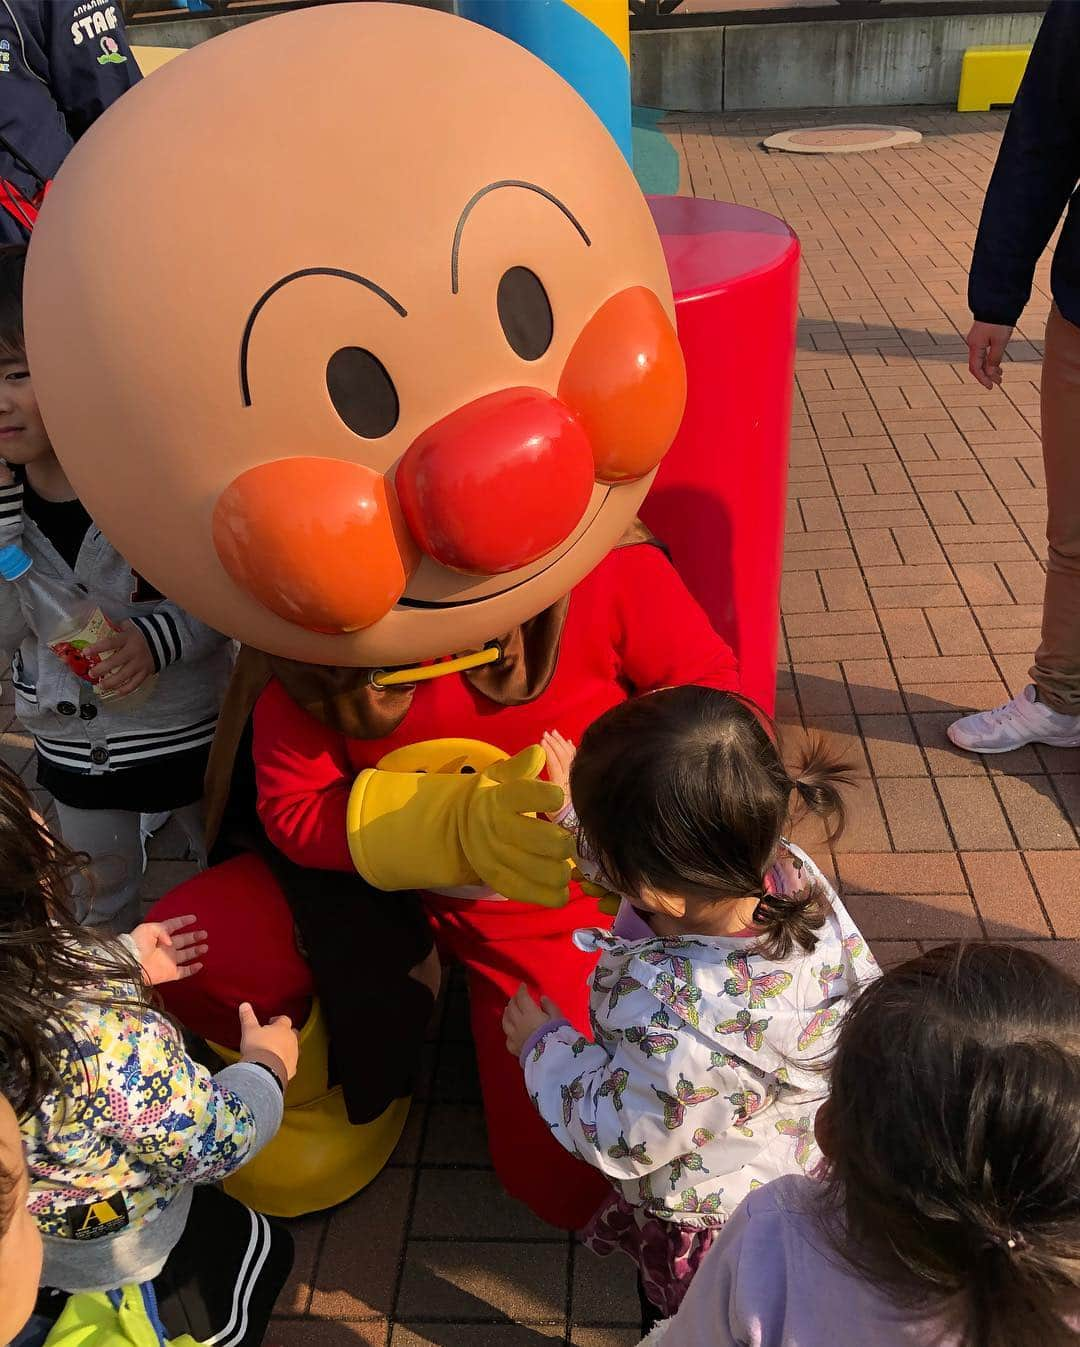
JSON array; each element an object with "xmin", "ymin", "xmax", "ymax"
[{"xmin": 504, "ymin": 687, "xmax": 877, "ymax": 1323}]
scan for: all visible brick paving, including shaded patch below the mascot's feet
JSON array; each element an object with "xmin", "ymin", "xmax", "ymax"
[{"xmin": 3, "ymin": 109, "xmax": 1080, "ymax": 1347}]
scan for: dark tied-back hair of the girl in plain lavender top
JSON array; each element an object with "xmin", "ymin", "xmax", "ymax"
[{"xmin": 821, "ymin": 944, "xmax": 1080, "ymax": 1347}]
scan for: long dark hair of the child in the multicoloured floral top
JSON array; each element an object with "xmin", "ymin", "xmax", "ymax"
[{"xmin": 0, "ymin": 764, "xmax": 147, "ymax": 1118}]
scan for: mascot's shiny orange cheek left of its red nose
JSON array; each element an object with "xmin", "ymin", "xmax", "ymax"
[{"xmin": 213, "ymin": 458, "xmax": 419, "ymax": 634}]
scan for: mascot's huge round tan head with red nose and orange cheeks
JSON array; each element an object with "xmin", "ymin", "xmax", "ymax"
[{"xmin": 27, "ymin": 4, "xmax": 685, "ymax": 665}]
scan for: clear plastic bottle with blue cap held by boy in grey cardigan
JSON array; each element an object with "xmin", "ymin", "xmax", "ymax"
[{"xmin": 0, "ymin": 547, "xmax": 155, "ymax": 706}]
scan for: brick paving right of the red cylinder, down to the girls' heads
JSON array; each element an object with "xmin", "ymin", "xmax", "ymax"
[{"xmin": 673, "ymin": 99, "xmax": 1080, "ymax": 966}]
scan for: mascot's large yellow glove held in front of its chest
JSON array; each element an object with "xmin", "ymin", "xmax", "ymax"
[{"xmin": 346, "ymin": 745, "xmax": 574, "ymax": 908}]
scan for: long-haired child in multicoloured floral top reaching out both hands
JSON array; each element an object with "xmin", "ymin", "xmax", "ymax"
[{"xmin": 0, "ymin": 764, "xmax": 298, "ymax": 1347}]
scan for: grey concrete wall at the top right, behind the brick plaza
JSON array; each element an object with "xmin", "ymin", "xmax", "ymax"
[{"xmin": 630, "ymin": 11, "xmax": 1044, "ymax": 112}]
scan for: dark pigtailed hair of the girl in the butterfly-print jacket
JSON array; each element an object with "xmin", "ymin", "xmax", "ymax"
[{"xmin": 570, "ymin": 686, "xmax": 851, "ymax": 959}]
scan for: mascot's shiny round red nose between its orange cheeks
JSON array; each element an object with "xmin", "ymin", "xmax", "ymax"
[{"xmin": 395, "ymin": 388, "xmax": 595, "ymax": 575}]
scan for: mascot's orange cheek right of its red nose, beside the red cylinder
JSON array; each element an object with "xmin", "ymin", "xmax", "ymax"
[{"xmin": 559, "ymin": 286, "xmax": 687, "ymax": 482}]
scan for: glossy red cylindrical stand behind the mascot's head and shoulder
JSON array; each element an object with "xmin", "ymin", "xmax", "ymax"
[{"xmin": 641, "ymin": 197, "xmax": 799, "ymax": 713}]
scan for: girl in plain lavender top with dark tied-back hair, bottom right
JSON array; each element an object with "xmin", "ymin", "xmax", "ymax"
[{"xmin": 650, "ymin": 944, "xmax": 1080, "ymax": 1347}]
